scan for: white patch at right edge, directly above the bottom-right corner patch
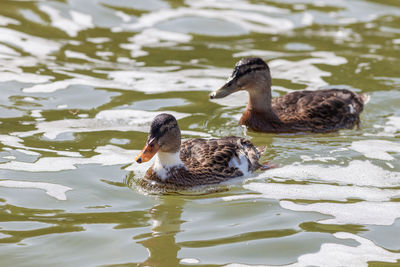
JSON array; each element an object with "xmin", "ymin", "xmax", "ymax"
[{"xmin": 280, "ymin": 201, "xmax": 400, "ymax": 225}]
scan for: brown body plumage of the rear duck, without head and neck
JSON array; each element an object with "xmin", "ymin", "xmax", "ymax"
[{"xmin": 240, "ymin": 89, "xmax": 364, "ymax": 133}]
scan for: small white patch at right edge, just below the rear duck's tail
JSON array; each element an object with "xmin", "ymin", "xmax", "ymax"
[{"xmin": 351, "ymin": 140, "xmax": 400, "ymax": 160}]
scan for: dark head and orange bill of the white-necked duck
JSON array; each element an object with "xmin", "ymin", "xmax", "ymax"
[{"xmin": 135, "ymin": 113, "xmax": 181, "ymax": 163}]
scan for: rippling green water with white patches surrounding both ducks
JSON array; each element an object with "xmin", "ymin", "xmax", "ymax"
[{"xmin": 0, "ymin": 0, "xmax": 400, "ymax": 266}]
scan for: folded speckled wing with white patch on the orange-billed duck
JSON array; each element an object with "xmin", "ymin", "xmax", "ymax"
[{"xmin": 180, "ymin": 136, "xmax": 260, "ymax": 177}]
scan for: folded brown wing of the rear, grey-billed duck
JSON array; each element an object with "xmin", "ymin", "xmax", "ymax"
[{"xmin": 272, "ymin": 89, "xmax": 367, "ymax": 132}]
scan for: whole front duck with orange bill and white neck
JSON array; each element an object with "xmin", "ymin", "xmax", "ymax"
[{"xmin": 135, "ymin": 113, "xmax": 270, "ymax": 191}]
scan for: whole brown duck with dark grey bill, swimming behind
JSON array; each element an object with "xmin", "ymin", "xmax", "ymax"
[{"xmin": 210, "ymin": 57, "xmax": 368, "ymax": 133}]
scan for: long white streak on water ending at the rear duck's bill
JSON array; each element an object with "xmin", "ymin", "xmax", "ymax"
[{"xmin": 22, "ymin": 63, "xmax": 225, "ymax": 93}]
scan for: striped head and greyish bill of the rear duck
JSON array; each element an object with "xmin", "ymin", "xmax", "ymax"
[{"xmin": 210, "ymin": 57, "xmax": 271, "ymax": 99}]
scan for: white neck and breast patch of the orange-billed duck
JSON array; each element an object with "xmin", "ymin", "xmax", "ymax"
[{"xmin": 153, "ymin": 151, "xmax": 185, "ymax": 181}]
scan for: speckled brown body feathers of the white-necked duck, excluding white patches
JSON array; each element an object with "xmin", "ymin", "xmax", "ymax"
[{"xmin": 139, "ymin": 136, "xmax": 260, "ymax": 193}]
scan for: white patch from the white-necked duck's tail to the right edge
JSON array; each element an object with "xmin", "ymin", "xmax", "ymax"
[{"xmin": 259, "ymin": 160, "xmax": 400, "ymax": 187}]
